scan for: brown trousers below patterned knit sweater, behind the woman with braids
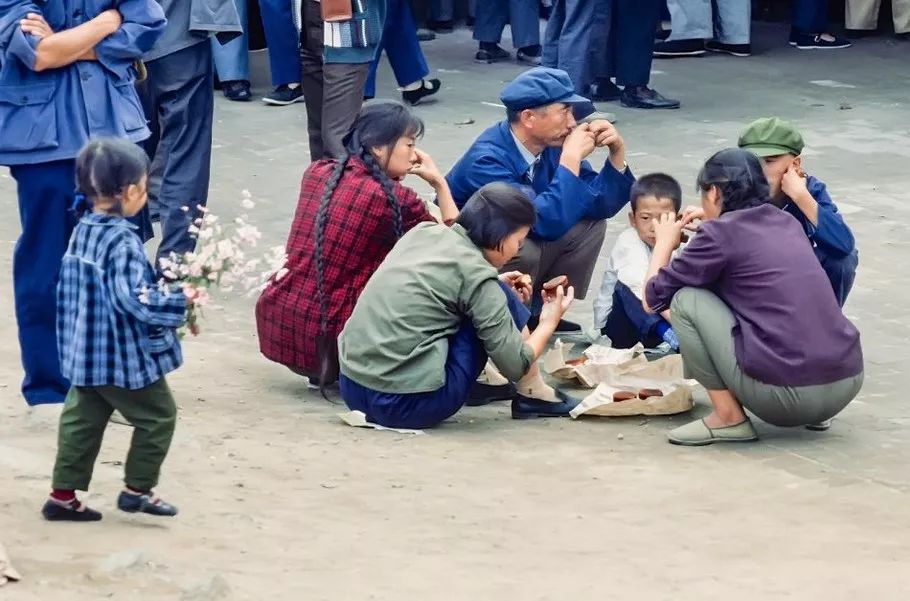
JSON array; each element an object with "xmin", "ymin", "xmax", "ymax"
[{"xmin": 320, "ymin": 63, "xmax": 370, "ymax": 158}]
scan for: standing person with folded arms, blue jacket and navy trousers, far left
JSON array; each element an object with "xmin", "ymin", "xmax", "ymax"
[{"xmin": 0, "ymin": 0, "xmax": 166, "ymax": 406}]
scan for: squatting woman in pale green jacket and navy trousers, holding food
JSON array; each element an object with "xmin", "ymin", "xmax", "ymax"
[{"xmin": 338, "ymin": 183, "xmax": 577, "ymax": 428}]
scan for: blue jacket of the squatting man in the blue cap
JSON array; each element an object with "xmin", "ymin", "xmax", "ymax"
[{"xmin": 446, "ymin": 121, "xmax": 635, "ymax": 240}]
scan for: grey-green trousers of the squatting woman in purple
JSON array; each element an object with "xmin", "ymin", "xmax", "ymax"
[{"xmin": 670, "ymin": 288, "xmax": 863, "ymax": 426}]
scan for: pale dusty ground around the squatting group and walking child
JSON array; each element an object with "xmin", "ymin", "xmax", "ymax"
[{"xmin": 0, "ymin": 21, "xmax": 910, "ymax": 601}]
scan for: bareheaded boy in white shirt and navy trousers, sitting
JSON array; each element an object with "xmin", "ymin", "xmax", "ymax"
[{"xmin": 594, "ymin": 173, "xmax": 682, "ymax": 350}]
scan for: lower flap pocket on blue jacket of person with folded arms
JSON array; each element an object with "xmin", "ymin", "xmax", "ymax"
[{"xmin": 0, "ymin": 82, "xmax": 60, "ymax": 152}]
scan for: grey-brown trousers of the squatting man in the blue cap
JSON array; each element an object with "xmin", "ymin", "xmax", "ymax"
[{"xmin": 502, "ymin": 220, "xmax": 607, "ymax": 299}]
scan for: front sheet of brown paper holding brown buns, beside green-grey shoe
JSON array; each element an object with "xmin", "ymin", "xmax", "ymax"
[{"xmin": 570, "ymin": 355, "xmax": 694, "ymax": 418}]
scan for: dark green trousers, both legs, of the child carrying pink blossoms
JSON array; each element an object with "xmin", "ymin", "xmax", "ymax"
[{"xmin": 53, "ymin": 378, "xmax": 177, "ymax": 491}]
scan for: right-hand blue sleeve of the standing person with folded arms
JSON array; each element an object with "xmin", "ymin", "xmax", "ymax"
[{"xmin": 95, "ymin": 0, "xmax": 167, "ymax": 79}]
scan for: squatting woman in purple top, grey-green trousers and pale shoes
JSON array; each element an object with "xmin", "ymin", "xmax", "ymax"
[{"xmin": 644, "ymin": 149, "xmax": 863, "ymax": 446}]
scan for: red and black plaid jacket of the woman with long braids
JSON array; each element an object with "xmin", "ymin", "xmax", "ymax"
[{"xmin": 256, "ymin": 158, "xmax": 433, "ymax": 373}]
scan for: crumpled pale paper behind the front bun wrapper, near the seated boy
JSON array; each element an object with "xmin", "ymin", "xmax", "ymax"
[{"xmin": 543, "ymin": 340, "xmax": 648, "ymax": 388}]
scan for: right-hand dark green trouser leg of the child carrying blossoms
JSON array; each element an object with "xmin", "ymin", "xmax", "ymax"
[{"xmin": 96, "ymin": 378, "xmax": 177, "ymax": 492}]
